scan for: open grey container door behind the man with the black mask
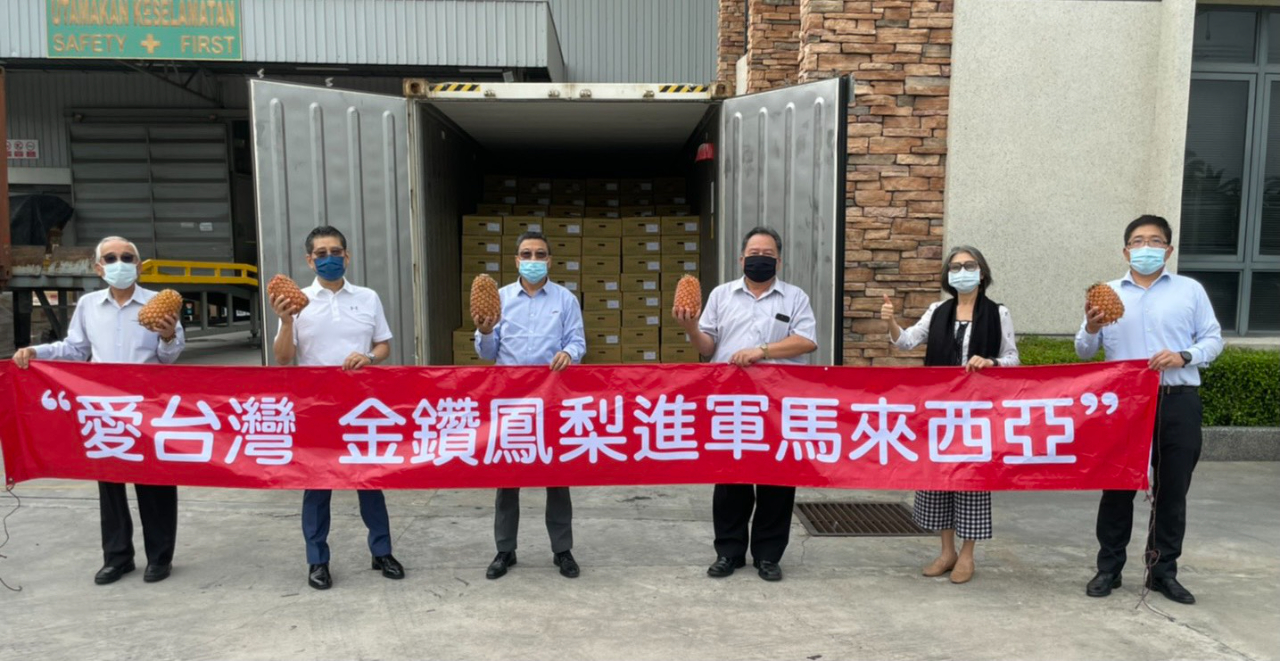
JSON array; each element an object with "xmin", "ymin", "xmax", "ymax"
[{"xmin": 716, "ymin": 78, "xmax": 849, "ymax": 365}]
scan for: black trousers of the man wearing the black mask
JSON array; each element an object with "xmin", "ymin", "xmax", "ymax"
[{"xmin": 712, "ymin": 484, "xmax": 796, "ymax": 562}]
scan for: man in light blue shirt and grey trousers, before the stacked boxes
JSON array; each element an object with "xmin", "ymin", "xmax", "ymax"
[{"xmin": 472, "ymin": 232, "xmax": 586, "ymax": 579}]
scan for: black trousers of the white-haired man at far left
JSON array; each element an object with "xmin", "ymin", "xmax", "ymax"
[{"xmin": 97, "ymin": 482, "xmax": 178, "ymax": 566}]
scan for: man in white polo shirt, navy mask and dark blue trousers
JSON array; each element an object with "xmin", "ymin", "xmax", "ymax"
[{"xmin": 271, "ymin": 225, "xmax": 404, "ymax": 589}]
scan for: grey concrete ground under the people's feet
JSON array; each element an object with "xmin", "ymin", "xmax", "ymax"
[{"xmin": 0, "ymin": 333, "xmax": 1280, "ymax": 661}]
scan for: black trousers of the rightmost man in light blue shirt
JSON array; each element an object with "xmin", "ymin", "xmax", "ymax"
[{"xmin": 1097, "ymin": 391, "xmax": 1203, "ymax": 578}]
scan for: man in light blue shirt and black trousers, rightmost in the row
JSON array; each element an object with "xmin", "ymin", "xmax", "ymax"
[{"xmin": 1075, "ymin": 215, "xmax": 1222, "ymax": 603}]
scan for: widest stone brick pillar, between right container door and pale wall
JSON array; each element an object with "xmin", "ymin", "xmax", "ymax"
[{"xmin": 778, "ymin": 0, "xmax": 952, "ymax": 365}]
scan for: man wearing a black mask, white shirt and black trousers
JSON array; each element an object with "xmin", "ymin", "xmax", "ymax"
[{"xmin": 672, "ymin": 227, "xmax": 818, "ymax": 580}]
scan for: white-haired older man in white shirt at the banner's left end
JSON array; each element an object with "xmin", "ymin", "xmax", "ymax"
[{"xmin": 13, "ymin": 237, "xmax": 186, "ymax": 585}]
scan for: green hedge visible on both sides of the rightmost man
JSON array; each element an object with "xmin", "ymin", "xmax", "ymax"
[{"xmin": 1018, "ymin": 336, "xmax": 1280, "ymax": 427}]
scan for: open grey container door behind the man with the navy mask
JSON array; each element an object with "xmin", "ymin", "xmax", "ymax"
[{"xmin": 250, "ymin": 79, "xmax": 419, "ymax": 365}]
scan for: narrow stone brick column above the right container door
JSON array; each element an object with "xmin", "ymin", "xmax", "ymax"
[{"xmin": 737, "ymin": 0, "xmax": 800, "ymax": 94}]
